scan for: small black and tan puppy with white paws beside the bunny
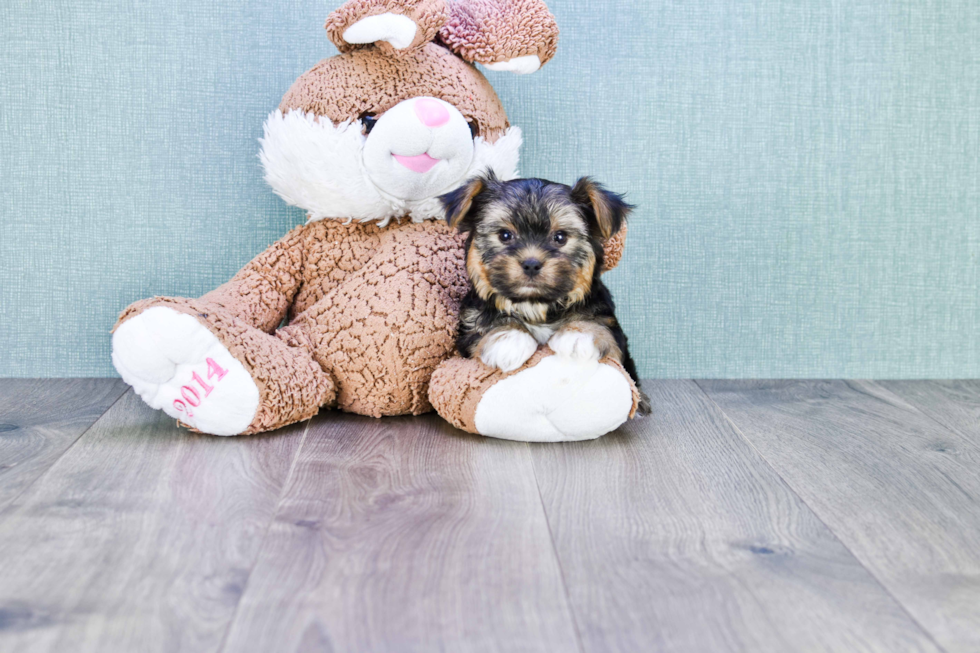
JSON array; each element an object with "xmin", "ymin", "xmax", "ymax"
[{"xmin": 439, "ymin": 172, "xmax": 650, "ymax": 415}]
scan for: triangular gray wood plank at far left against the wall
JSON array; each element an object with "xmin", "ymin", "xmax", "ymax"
[{"xmin": 0, "ymin": 379, "xmax": 127, "ymax": 509}]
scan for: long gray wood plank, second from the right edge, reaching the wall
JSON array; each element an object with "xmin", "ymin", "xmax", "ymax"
[{"xmin": 702, "ymin": 381, "xmax": 980, "ymax": 652}]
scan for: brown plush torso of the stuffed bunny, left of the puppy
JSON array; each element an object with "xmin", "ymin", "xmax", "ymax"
[{"xmin": 279, "ymin": 221, "xmax": 468, "ymax": 417}]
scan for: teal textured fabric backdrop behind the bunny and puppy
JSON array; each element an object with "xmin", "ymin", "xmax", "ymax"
[{"xmin": 0, "ymin": 0, "xmax": 980, "ymax": 377}]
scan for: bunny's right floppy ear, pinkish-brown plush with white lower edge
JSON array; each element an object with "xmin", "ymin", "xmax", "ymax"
[{"xmin": 439, "ymin": 0, "xmax": 558, "ymax": 74}]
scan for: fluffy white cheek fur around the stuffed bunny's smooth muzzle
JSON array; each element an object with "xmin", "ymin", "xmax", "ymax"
[{"xmin": 259, "ymin": 110, "xmax": 522, "ymax": 225}]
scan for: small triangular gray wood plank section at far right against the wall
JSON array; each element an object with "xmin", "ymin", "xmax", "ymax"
[{"xmin": 876, "ymin": 380, "xmax": 980, "ymax": 444}]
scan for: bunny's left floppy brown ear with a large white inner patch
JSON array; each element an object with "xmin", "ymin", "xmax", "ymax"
[{"xmin": 325, "ymin": 0, "xmax": 447, "ymax": 56}]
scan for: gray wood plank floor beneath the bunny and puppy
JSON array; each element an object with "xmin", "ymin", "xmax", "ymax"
[{"xmin": 0, "ymin": 380, "xmax": 980, "ymax": 653}]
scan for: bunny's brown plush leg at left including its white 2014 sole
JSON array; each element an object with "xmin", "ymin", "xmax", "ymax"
[{"xmin": 112, "ymin": 298, "xmax": 335, "ymax": 435}]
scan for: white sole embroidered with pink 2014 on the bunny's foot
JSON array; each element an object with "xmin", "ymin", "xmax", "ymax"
[{"xmin": 112, "ymin": 306, "xmax": 259, "ymax": 435}]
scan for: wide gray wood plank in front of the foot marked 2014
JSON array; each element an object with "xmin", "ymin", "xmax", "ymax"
[{"xmin": 0, "ymin": 392, "xmax": 304, "ymax": 653}]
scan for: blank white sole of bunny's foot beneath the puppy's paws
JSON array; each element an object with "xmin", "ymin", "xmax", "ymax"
[{"xmin": 474, "ymin": 355, "xmax": 633, "ymax": 442}]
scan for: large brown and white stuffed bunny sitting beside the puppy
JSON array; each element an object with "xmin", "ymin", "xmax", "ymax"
[{"xmin": 112, "ymin": 0, "xmax": 638, "ymax": 441}]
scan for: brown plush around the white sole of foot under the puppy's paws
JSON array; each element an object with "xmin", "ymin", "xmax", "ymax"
[{"xmin": 429, "ymin": 346, "xmax": 640, "ymax": 433}]
